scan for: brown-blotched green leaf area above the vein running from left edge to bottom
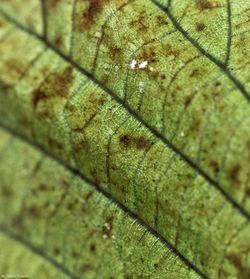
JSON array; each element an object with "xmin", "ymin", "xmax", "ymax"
[{"xmin": 0, "ymin": 0, "xmax": 250, "ymax": 278}]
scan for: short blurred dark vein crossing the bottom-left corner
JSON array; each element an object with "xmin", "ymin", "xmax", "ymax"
[{"xmin": 0, "ymin": 225, "xmax": 79, "ymax": 279}]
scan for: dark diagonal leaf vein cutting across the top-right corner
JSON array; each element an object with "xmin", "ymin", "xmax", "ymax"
[{"xmin": 150, "ymin": 0, "xmax": 250, "ymax": 102}]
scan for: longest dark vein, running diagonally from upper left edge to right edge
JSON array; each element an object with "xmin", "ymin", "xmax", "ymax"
[{"xmin": 0, "ymin": 9, "xmax": 250, "ymax": 220}]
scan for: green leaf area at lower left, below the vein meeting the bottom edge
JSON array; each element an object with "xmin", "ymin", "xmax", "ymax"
[{"xmin": 0, "ymin": 129, "xmax": 199, "ymax": 278}]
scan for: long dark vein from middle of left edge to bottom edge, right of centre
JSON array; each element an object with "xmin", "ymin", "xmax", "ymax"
[{"xmin": 0, "ymin": 121, "xmax": 209, "ymax": 279}]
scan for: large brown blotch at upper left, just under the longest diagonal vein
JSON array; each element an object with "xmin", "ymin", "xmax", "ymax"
[{"xmin": 32, "ymin": 66, "xmax": 73, "ymax": 107}]
